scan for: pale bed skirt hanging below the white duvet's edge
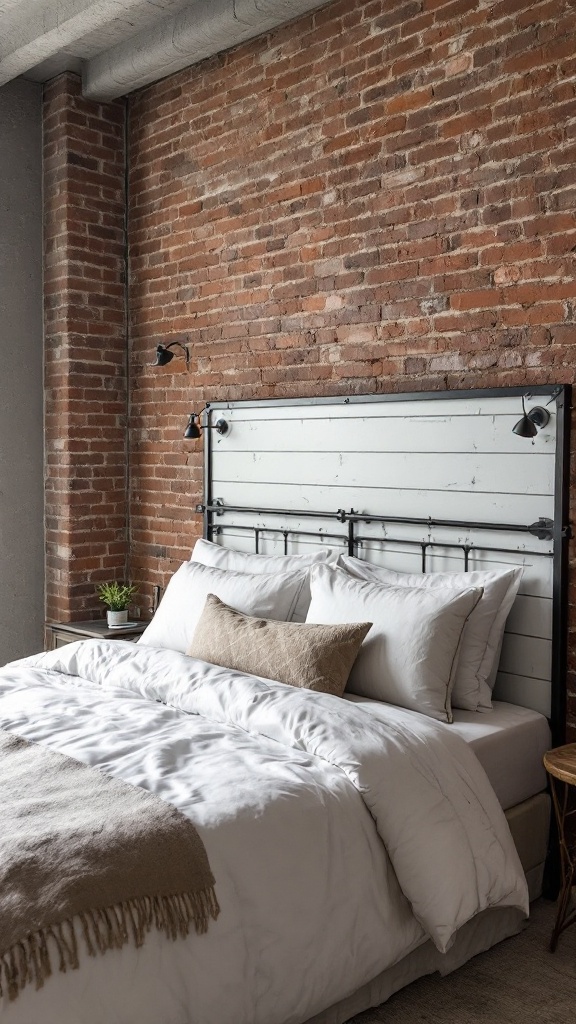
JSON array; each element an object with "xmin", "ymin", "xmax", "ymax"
[{"xmin": 305, "ymin": 793, "xmax": 550, "ymax": 1024}]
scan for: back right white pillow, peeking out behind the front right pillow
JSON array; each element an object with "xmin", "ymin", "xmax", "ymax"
[{"xmin": 338, "ymin": 555, "xmax": 522, "ymax": 711}]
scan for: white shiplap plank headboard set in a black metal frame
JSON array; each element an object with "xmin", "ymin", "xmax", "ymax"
[{"xmin": 199, "ymin": 385, "xmax": 570, "ymax": 740}]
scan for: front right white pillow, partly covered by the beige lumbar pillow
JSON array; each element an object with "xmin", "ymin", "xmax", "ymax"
[{"xmin": 306, "ymin": 565, "xmax": 482, "ymax": 722}]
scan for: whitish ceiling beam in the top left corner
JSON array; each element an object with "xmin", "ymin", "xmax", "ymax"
[{"xmin": 0, "ymin": 0, "xmax": 152, "ymax": 86}]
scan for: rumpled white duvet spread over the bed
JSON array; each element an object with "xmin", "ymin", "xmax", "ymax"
[{"xmin": 0, "ymin": 640, "xmax": 528, "ymax": 1024}]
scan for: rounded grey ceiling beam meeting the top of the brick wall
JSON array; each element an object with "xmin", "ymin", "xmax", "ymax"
[{"xmin": 82, "ymin": 0, "xmax": 326, "ymax": 101}]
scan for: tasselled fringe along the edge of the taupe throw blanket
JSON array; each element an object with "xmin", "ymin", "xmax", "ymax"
[{"xmin": 0, "ymin": 886, "xmax": 220, "ymax": 1000}]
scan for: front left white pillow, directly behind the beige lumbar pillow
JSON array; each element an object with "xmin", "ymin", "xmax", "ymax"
[{"xmin": 137, "ymin": 562, "xmax": 307, "ymax": 654}]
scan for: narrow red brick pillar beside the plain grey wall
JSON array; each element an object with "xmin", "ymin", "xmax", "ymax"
[{"xmin": 44, "ymin": 75, "xmax": 127, "ymax": 620}]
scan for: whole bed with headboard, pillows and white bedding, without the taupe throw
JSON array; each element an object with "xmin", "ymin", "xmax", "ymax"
[{"xmin": 0, "ymin": 387, "xmax": 568, "ymax": 1024}]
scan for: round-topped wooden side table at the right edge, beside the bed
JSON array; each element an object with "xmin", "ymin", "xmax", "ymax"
[{"xmin": 543, "ymin": 743, "xmax": 576, "ymax": 952}]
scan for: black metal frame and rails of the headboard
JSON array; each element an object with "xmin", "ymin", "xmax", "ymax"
[{"xmin": 196, "ymin": 384, "xmax": 572, "ymax": 743}]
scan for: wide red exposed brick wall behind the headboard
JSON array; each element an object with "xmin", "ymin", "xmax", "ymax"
[{"xmin": 129, "ymin": 0, "xmax": 576, "ymax": 738}]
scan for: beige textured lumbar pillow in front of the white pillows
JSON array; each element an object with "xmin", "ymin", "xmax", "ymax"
[{"xmin": 187, "ymin": 594, "xmax": 372, "ymax": 696}]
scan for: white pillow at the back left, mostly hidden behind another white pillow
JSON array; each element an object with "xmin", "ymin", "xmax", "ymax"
[{"xmin": 192, "ymin": 540, "xmax": 337, "ymax": 623}]
